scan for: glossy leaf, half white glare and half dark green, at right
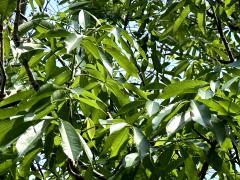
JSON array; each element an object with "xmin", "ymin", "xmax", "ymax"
[{"xmin": 190, "ymin": 100, "xmax": 211, "ymax": 127}]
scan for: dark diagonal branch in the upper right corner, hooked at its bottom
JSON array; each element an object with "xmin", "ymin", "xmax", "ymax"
[{"xmin": 208, "ymin": 0, "xmax": 235, "ymax": 64}]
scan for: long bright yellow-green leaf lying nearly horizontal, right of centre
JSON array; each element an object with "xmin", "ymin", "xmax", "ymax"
[{"xmin": 161, "ymin": 80, "xmax": 207, "ymax": 99}]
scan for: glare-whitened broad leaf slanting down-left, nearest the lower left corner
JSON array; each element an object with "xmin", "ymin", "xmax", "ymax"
[{"xmin": 16, "ymin": 121, "xmax": 46, "ymax": 156}]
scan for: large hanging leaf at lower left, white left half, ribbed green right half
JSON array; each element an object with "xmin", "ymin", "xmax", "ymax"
[{"xmin": 59, "ymin": 120, "xmax": 82, "ymax": 163}]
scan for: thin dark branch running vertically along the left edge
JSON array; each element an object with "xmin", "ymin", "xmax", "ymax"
[{"xmin": 0, "ymin": 17, "xmax": 7, "ymax": 101}]
